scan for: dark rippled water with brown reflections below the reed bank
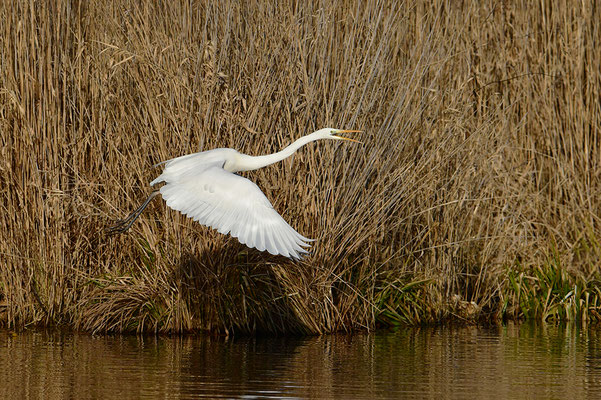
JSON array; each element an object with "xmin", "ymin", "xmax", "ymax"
[{"xmin": 0, "ymin": 325, "xmax": 601, "ymax": 399}]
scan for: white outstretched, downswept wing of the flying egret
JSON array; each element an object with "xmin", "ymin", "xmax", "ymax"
[{"xmin": 153, "ymin": 163, "xmax": 311, "ymax": 259}]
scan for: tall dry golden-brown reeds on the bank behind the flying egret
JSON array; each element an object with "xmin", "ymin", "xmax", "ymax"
[{"xmin": 0, "ymin": 0, "xmax": 601, "ymax": 333}]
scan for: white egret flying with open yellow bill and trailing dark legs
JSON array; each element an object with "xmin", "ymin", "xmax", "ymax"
[{"xmin": 108, "ymin": 128, "xmax": 361, "ymax": 259}]
